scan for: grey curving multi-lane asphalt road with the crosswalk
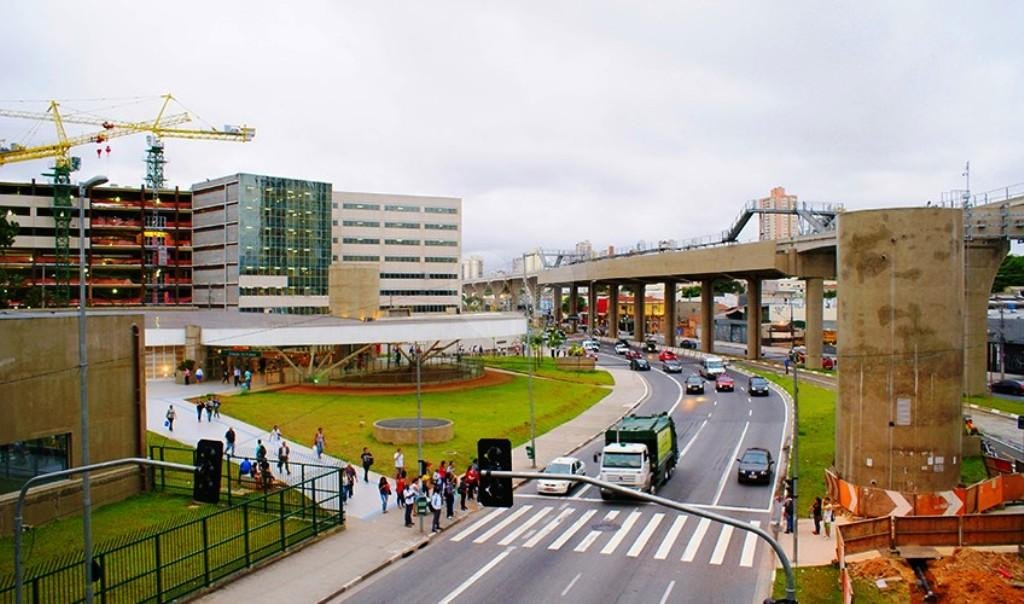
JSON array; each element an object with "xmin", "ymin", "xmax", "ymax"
[{"xmin": 343, "ymin": 347, "xmax": 786, "ymax": 603}]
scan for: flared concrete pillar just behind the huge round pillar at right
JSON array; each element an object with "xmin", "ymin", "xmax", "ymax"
[{"xmin": 964, "ymin": 240, "xmax": 1010, "ymax": 394}]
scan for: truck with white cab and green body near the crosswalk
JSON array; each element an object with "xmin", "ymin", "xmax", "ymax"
[{"xmin": 598, "ymin": 413, "xmax": 679, "ymax": 500}]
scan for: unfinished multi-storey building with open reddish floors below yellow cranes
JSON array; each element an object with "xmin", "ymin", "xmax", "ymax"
[{"xmin": 0, "ymin": 181, "xmax": 193, "ymax": 308}]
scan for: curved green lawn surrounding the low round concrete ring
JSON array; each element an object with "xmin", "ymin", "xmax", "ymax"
[{"xmin": 223, "ymin": 377, "xmax": 610, "ymax": 471}]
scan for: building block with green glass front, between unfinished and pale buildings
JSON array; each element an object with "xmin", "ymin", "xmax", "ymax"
[{"xmin": 193, "ymin": 174, "xmax": 332, "ymax": 314}]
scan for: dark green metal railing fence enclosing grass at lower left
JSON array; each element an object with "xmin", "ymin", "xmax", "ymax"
[{"xmin": 0, "ymin": 446, "xmax": 344, "ymax": 604}]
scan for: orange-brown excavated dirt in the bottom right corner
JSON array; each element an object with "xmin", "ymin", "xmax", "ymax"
[{"xmin": 849, "ymin": 549, "xmax": 1024, "ymax": 604}]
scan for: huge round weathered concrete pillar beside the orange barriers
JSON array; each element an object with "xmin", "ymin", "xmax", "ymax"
[{"xmin": 835, "ymin": 208, "xmax": 964, "ymax": 495}]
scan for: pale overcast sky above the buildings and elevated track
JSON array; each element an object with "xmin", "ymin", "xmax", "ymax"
[{"xmin": 0, "ymin": 0, "xmax": 1024, "ymax": 272}]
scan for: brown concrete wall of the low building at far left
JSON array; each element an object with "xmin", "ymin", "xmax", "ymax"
[{"xmin": 0, "ymin": 313, "xmax": 145, "ymax": 534}]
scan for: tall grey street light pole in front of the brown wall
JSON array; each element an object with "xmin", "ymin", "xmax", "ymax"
[{"xmin": 78, "ymin": 176, "xmax": 106, "ymax": 604}]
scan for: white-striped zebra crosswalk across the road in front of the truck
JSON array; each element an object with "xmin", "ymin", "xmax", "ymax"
[{"xmin": 450, "ymin": 505, "xmax": 762, "ymax": 568}]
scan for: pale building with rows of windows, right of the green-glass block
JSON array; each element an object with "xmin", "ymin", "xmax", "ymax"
[{"xmin": 331, "ymin": 191, "xmax": 462, "ymax": 313}]
